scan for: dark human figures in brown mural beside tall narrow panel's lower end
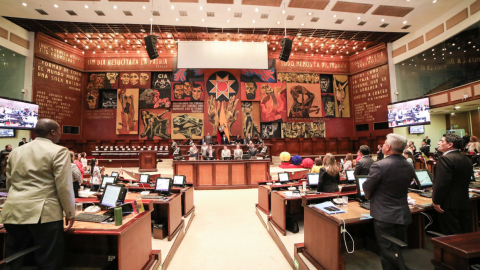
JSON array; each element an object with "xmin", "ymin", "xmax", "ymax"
[{"xmin": 140, "ymin": 109, "xmax": 170, "ymax": 140}]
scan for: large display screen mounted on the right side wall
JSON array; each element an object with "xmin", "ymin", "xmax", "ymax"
[{"xmin": 388, "ymin": 97, "xmax": 430, "ymax": 128}]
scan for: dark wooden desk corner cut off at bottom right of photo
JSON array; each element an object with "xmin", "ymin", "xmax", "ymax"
[{"xmin": 432, "ymin": 232, "xmax": 480, "ymax": 270}]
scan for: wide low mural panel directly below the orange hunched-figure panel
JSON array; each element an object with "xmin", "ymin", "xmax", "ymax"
[{"xmin": 282, "ymin": 122, "xmax": 325, "ymax": 138}]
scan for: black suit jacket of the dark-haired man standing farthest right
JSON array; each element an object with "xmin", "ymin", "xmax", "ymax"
[{"xmin": 433, "ymin": 151, "xmax": 473, "ymax": 209}]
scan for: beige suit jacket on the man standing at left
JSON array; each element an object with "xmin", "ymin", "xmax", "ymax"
[{"xmin": 0, "ymin": 138, "xmax": 75, "ymax": 224}]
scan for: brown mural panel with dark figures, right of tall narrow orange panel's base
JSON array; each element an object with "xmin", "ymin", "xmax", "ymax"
[{"xmin": 140, "ymin": 108, "xmax": 171, "ymax": 140}]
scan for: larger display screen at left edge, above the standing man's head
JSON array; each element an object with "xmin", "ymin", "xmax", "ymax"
[{"xmin": 0, "ymin": 97, "xmax": 38, "ymax": 129}]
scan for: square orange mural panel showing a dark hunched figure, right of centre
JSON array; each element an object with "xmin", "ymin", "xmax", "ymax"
[{"xmin": 287, "ymin": 83, "xmax": 324, "ymax": 118}]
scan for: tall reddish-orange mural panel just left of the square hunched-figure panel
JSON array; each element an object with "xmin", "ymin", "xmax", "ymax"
[{"xmin": 257, "ymin": 83, "xmax": 287, "ymax": 122}]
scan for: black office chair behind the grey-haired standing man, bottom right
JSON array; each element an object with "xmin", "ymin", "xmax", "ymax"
[{"xmin": 382, "ymin": 231, "xmax": 445, "ymax": 270}]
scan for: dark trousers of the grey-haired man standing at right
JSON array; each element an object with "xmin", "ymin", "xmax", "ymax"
[{"xmin": 373, "ymin": 220, "xmax": 407, "ymax": 270}]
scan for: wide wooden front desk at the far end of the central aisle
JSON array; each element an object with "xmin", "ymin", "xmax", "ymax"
[{"xmin": 173, "ymin": 159, "xmax": 270, "ymax": 189}]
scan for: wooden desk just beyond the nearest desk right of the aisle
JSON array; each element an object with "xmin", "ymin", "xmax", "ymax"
[{"xmin": 271, "ymin": 191, "xmax": 357, "ymax": 235}]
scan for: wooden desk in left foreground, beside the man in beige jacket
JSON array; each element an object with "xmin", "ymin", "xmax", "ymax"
[{"xmin": 0, "ymin": 207, "xmax": 152, "ymax": 270}]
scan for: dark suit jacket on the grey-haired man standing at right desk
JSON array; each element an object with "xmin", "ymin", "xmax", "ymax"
[{"xmin": 363, "ymin": 155, "xmax": 415, "ymax": 225}]
